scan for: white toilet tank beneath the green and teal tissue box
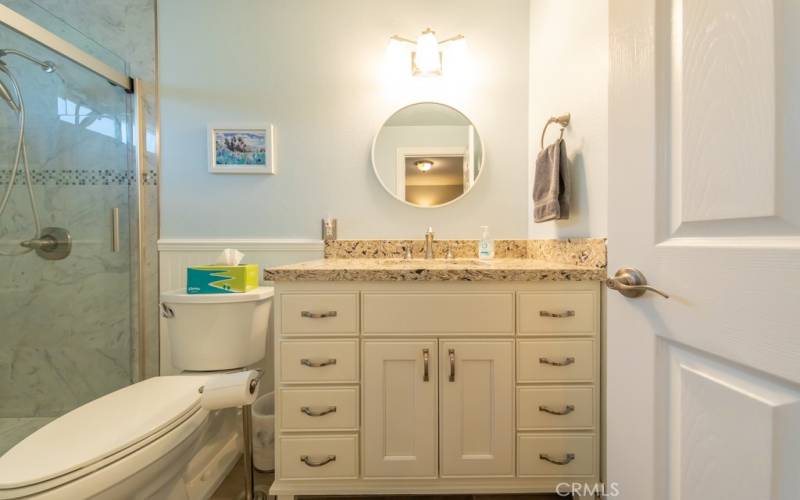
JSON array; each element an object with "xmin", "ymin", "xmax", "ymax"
[{"xmin": 161, "ymin": 287, "xmax": 273, "ymax": 371}]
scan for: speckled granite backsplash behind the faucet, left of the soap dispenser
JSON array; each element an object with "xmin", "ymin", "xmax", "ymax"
[{"xmin": 325, "ymin": 240, "xmax": 478, "ymax": 259}]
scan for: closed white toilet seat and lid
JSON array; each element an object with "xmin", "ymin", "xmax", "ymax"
[{"xmin": 0, "ymin": 374, "xmax": 210, "ymax": 498}]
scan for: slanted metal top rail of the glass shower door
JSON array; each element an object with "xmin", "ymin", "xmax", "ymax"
[{"xmin": 0, "ymin": 5, "xmax": 134, "ymax": 94}]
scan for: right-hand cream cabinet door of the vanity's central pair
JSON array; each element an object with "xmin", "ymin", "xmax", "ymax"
[{"xmin": 439, "ymin": 340, "xmax": 514, "ymax": 477}]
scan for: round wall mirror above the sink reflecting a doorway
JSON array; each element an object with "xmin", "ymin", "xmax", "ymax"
[{"xmin": 372, "ymin": 102, "xmax": 483, "ymax": 207}]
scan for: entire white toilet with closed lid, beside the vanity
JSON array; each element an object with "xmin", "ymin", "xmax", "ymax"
[{"xmin": 0, "ymin": 287, "xmax": 273, "ymax": 500}]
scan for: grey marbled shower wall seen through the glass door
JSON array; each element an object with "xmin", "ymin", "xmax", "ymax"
[{"xmin": 0, "ymin": 0, "xmax": 158, "ymax": 417}]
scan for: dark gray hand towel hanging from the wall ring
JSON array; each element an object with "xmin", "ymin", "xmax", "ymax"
[{"xmin": 533, "ymin": 139, "xmax": 570, "ymax": 222}]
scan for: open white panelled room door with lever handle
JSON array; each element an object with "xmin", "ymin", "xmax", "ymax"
[{"xmin": 605, "ymin": 0, "xmax": 800, "ymax": 500}]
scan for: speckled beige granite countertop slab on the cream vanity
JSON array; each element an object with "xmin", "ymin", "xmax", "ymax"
[{"xmin": 264, "ymin": 258, "xmax": 606, "ymax": 281}]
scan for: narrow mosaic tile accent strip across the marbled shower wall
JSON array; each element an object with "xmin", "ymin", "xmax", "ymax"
[{"xmin": 0, "ymin": 168, "xmax": 158, "ymax": 186}]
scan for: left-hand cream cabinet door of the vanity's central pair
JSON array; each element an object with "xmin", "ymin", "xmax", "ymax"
[{"xmin": 361, "ymin": 340, "xmax": 437, "ymax": 478}]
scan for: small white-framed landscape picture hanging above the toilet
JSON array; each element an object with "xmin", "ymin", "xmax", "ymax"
[{"xmin": 208, "ymin": 123, "xmax": 275, "ymax": 175}]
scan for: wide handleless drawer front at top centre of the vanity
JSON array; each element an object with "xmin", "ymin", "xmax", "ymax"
[{"xmin": 362, "ymin": 292, "xmax": 514, "ymax": 335}]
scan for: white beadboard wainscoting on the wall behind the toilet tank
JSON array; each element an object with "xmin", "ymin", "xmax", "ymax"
[{"xmin": 158, "ymin": 239, "xmax": 324, "ymax": 382}]
